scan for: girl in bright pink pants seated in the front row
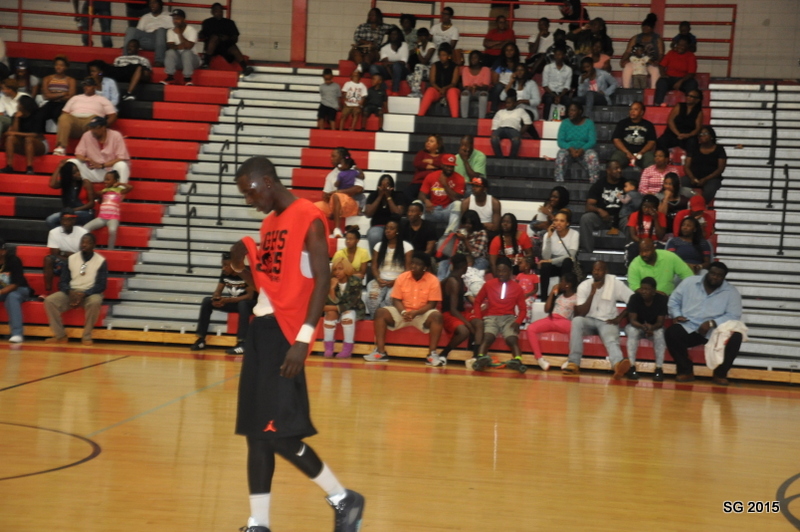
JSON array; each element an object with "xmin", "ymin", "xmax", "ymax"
[{"xmin": 527, "ymin": 272, "xmax": 578, "ymax": 371}]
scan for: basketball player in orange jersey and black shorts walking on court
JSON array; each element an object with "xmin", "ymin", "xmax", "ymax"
[{"xmin": 225, "ymin": 157, "xmax": 364, "ymax": 532}]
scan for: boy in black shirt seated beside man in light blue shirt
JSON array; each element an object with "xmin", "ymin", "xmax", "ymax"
[{"xmin": 625, "ymin": 277, "xmax": 669, "ymax": 382}]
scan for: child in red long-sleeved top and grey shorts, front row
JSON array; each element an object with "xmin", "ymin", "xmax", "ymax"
[{"xmin": 473, "ymin": 257, "xmax": 528, "ymax": 360}]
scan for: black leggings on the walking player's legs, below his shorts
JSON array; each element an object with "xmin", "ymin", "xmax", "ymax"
[{"xmin": 247, "ymin": 436, "xmax": 322, "ymax": 494}]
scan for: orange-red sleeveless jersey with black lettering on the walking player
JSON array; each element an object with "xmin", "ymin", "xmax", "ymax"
[{"xmin": 242, "ymin": 198, "xmax": 327, "ymax": 343}]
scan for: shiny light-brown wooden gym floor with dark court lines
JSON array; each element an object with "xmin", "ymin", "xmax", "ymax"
[{"xmin": 0, "ymin": 342, "xmax": 800, "ymax": 532}]
